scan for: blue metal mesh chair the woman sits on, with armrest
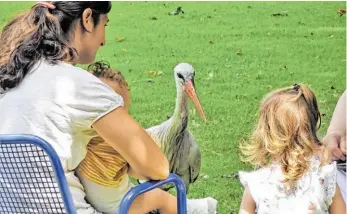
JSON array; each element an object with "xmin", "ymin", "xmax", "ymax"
[{"xmin": 0, "ymin": 135, "xmax": 186, "ymax": 214}]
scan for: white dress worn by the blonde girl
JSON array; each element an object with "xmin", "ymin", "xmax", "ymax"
[{"xmin": 239, "ymin": 157, "xmax": 337, "ymax": 214}]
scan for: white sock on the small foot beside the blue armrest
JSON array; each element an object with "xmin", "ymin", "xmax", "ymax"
[{"xmin": 187, "ymin": 197, "xmax": 217, "ymax": 214}]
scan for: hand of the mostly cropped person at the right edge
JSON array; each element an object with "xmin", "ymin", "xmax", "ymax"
[{"xmin": 323, "ymin": 131, "xmax": 346, "ymax": 161}]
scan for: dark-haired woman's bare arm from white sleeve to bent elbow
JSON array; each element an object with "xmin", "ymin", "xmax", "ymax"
[{"xmin": 93, "ymin": 107, "xmax": 169, "ymax": 180}]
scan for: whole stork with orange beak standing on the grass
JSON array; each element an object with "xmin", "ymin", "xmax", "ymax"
[{"xmin": 146, "ymin": 63, "xmax": 206, "ymax": 193}]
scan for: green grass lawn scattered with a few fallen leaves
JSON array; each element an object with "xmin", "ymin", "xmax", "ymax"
[{"xmin": 0, "ymin": 2, "xmax": 346, "ymax": 214}]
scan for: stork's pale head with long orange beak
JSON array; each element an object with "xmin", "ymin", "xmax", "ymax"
[{"xmin": 174, "ymin": 63, "xmax": 206, "ymax": 121}]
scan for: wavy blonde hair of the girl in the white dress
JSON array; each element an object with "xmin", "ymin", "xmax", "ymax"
[{"xmin": 240, "ymin": 84, "xmax": 329, "ymax": 187}]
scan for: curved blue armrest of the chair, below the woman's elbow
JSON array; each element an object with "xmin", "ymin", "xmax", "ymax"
[{"xmin": 119, "ymin": 173, "xmax": 187, "ymax": 214}]
